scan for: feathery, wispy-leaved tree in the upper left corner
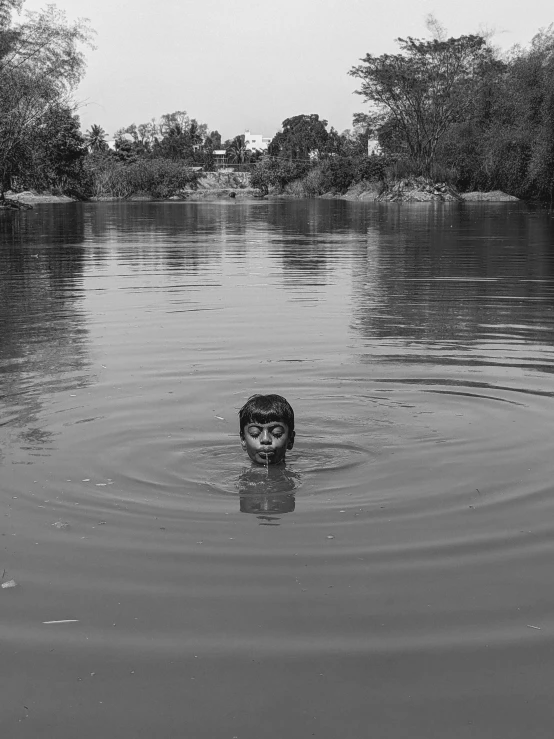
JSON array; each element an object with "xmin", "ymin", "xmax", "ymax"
[{"xmin": 0, "ymin": 0, "xmax": 91, "ymax": 198}]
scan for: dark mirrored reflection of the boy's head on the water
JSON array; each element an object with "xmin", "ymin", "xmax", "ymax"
[{"xmin": 237, "ymin": 464, "xmax": 300, "ymax": 525}]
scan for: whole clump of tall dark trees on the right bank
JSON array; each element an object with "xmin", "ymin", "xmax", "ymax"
[{"xmin": 350, "ymin": 19, "xmax": 554, "ymax": 203}]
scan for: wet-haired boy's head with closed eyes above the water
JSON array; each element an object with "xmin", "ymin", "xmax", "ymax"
[{"xmin": 239, "ymin": 395, "xmax": 294, "ymax": 465}]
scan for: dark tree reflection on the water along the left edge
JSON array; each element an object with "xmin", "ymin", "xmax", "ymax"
[{"xmin": 0, "ymin": 205, "xmax": 90, "ymax": 452}]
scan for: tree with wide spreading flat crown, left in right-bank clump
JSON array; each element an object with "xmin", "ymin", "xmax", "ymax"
[{"xmin": 349, "ymin": 34, "xmax": 498, "ymax": 173}]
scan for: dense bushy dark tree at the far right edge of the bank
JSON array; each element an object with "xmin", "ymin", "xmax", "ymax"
[{"xmin": 437, "ymin": 26, "xmax": 554, "ymax": 202}]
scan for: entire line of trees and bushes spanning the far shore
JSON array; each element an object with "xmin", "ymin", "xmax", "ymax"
[{"xmin": 0, "ymin": 0, "xmax": 554, "ymax": 204}]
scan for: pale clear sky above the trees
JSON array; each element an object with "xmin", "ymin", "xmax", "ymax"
[{"xmin": 19, "ymin": 0, "xmax": 554, "ymax": 139}]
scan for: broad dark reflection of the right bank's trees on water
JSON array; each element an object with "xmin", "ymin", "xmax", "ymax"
[{"xmin": 354, "ymin": 205, "xmax": 554, "ymax": 354}]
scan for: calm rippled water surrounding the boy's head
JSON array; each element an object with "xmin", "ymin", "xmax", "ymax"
[{"xmin": 0, "ymin": 201, "xmax": 554, "ymax": 739}]
